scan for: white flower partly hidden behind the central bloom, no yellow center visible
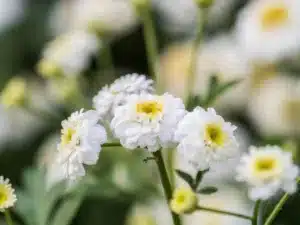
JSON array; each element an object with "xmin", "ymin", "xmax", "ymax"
[{"xmin": 93, "ymin": 74, "xmax": 154, "ymax": 119}]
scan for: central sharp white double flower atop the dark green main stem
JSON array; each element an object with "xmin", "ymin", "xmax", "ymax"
[{"xmin": 111, "ymin": 93, "xmax": 185, "ymax": 152}]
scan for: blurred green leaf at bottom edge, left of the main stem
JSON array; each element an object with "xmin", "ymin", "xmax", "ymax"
[{"xmin": 50, "ymin": 194, "xmax": 84, "ymax": 225}]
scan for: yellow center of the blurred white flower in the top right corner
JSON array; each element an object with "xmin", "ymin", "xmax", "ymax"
[{"xmin": 261, "ymin": 4, "xmax": 289, "ymax": 30}]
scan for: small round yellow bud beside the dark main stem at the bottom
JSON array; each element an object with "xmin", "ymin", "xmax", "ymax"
[{"xmin": 170, "ymin": 188, "xmax": 198, "ymax": 214}]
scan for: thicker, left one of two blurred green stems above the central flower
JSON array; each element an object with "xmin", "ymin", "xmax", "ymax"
[{"xmin": 140, "ymin": 6, "xmax": 163, "ymax": 92}]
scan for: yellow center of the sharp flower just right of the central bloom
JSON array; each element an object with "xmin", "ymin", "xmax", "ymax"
[{"xmin": 204, "ymin": 124, "xmax": 226, "ymax": 146}]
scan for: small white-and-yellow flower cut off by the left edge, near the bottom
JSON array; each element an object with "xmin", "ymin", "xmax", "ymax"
[{"xmin": 0, "ymin": 176, "xmax": 17, "ymax": 212}]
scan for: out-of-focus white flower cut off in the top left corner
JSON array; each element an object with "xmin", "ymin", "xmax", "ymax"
[{"xmin": 0, "ymin": 0, "xmax": 26, "ymax": 32}]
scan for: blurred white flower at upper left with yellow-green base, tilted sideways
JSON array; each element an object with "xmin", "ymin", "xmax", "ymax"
[{"xmin": 37, "ymin": 30, "xmax": 101, "ymax": 77}]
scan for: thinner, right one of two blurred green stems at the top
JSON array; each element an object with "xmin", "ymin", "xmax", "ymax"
[{"xmin": 187, "ymin": 8, "xmax": 207, "ymax": 97}]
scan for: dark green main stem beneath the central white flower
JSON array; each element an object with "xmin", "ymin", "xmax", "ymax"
[{"xmin": 153, "ymin": 150, "xmax": 181, "ymax": 225}]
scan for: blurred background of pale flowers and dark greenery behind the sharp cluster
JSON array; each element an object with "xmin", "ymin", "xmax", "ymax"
[{"xmin": 0, "ymin": 0, "xmax": 300, "ymax": 225}]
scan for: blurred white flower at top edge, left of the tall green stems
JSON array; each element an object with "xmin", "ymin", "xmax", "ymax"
[{"xmin": 71, "ymin": 0, "xmax": 137, "ymax": 34}]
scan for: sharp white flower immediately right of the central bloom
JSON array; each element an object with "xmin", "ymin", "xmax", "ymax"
[{"xmin": 175, "ymin": 107, "xmax": 237, "ymax": 169}]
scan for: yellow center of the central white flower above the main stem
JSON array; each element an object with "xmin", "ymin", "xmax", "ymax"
[{"xmin": 136, "ymin": 101, "xmax": 163, "ymax": 119}]
